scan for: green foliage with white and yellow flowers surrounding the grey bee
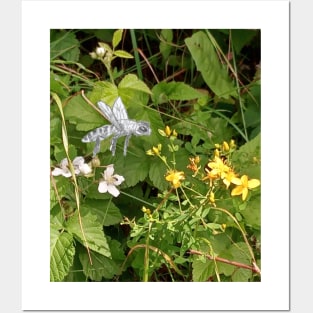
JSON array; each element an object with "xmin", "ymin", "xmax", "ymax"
[{"xmin": 50, "ymin": 29, "xmax": 261, "ymax": 282}]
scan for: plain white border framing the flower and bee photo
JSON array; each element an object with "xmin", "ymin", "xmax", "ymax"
[{"xmin": 22, "ymin": 1, "xmax": 289, "ymax": 311}]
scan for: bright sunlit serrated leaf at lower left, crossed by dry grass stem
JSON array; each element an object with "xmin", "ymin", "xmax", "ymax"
[{"xmin": 66, "ymin": 213, "xmax": 111, "ymax": 257}]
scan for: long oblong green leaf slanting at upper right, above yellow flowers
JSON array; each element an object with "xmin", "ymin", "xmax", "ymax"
[{"xmin": 185, "ymin": 31, "xmax": 237, "ymax": 99}]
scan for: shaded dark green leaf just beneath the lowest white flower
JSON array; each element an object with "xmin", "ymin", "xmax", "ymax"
[{"xmin": 81, "ymin": 199, "xmax": 123, "ymax": 226}]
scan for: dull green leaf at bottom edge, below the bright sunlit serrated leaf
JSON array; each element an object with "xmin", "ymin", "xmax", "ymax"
[{"xmin": 79, "ymin": 251, "xmax": 119, "ymax": 281}]
